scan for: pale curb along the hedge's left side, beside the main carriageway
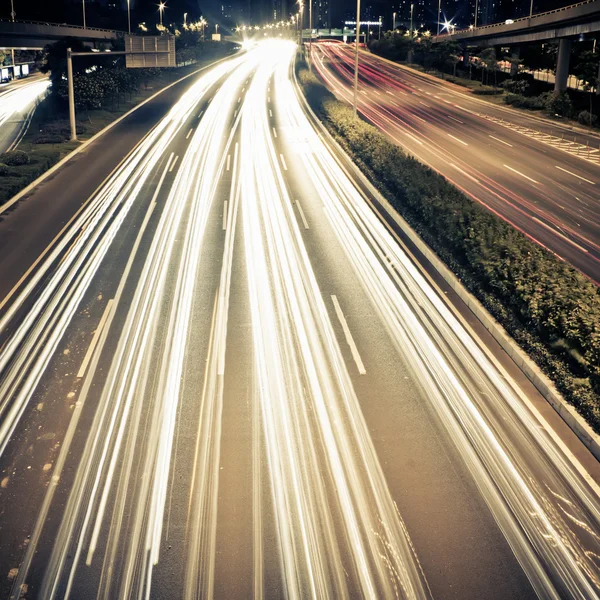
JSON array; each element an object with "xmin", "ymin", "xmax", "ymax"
[{"xmin": 294, "ymin": 63, "xmax": 600, "ymax": 460}]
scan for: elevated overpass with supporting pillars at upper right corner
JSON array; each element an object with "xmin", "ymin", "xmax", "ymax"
[{"xmin": 433, "ymin": 0, "xmax": 600, "ymax": 92}]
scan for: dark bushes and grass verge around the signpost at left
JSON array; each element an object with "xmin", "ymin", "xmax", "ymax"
[{"xmin": 0, "ymin": 35, "xmax": 239, "ymax": 209}]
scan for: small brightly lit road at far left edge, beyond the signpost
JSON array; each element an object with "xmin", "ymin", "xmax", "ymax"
[{"xmin": 0, "ymin": 75, "xmax": 50, "ymax": 153}]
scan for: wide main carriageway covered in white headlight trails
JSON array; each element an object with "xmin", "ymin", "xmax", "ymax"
[{"xmin": 0, "ymin": 41, "xmax": 600, "ymax": 599}]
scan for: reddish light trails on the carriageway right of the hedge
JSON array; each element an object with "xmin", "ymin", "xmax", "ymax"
[{"xmin": 313, "ymin": 43, "xmax": 600, "ymax": 280}]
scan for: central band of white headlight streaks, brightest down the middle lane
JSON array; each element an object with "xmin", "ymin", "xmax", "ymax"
[{"xmin": 240, "ymin": 43, "xmax": 429, "ymax": 598}]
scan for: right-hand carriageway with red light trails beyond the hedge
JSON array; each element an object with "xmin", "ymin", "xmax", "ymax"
[{"xmin": 313, "ymin": 43, "xmax": 600, "ymax": 282}]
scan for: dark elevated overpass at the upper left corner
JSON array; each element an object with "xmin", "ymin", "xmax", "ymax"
[{"xmin": 0, "ymin": 19, "xmax": 125, "ymax": 50}]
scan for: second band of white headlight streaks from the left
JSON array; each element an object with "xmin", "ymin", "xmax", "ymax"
[{"xmin": 44, "ymin": 58, "xmax": 253, "ymax": 599}]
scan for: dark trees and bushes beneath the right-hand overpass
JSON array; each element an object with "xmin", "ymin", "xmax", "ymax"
[{"xmin": 369, "ymin": 30, "xmax": 600, "ymax": 127}]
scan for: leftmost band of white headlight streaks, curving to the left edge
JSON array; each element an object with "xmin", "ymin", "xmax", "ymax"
[{"xmin": 0, "ymin": 59, "xmax": 246, "ymax": 455}]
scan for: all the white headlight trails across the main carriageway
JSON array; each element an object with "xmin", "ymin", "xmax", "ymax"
[{"xmin": 0, "ymin": 41, "xmax": 600, "ymax": 600}]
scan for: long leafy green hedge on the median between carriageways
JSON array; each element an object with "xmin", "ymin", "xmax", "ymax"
[{"xmin": 297, "ymin": 64, "xmax": 600, "ymax": 432}]
